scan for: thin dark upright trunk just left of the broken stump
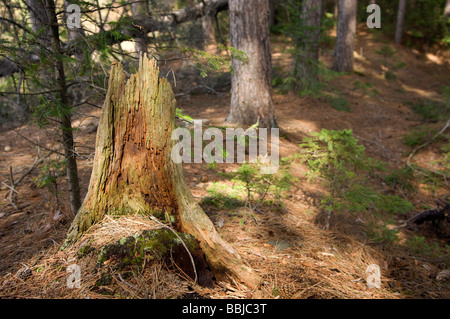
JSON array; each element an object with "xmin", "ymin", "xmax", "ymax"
[{"xmin": 45, "ymin": 0, "xmax": 81, "ymax": 214}]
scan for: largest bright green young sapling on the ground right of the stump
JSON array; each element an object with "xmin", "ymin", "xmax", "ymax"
[{"xmin": 299, "ymin": 129, "xmax": 412, "ymax": 218}]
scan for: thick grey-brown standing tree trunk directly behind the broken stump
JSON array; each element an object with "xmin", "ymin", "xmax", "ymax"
[{"xmin": 228, "ymin": 0, "xmax": 277, "ymax": 128}]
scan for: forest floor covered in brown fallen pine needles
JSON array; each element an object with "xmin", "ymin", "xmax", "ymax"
[{"xmin": 0, "ymin": 25, "xmax": 450, "ymax": 299}]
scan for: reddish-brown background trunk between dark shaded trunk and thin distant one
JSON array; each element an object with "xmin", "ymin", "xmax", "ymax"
[{"xmin": 333, "ymin": 0, "xmax": 358, "ymax": 72}]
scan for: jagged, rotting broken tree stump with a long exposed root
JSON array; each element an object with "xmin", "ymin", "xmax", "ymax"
[{"xmin": 66, "ymin": 56, "xmax": 259, "ymax": 287}]
